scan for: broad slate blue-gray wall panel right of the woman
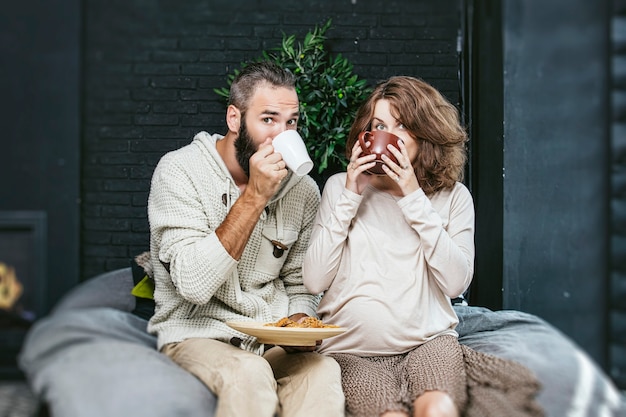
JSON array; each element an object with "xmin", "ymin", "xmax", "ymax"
[{"xmin": 502, "ymin": 0, "xmax": 610, "ymax": 366}]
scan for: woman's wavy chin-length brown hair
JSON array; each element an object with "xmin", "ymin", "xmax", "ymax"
[{"xmin": 346, "ymin": 76, "xmax": 468, "ymax": 195}]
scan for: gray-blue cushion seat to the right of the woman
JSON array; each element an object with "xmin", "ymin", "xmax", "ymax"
[{"xmin": 455, "ymin": 306, "xmax": 626, "ymax": 417}]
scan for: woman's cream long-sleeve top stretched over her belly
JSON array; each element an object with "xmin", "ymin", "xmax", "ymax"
[{"xmin": 303, "ymin": 173, "xmax": 474, "ymax": 356}]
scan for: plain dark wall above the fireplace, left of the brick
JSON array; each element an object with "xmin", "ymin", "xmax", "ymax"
[{"xmin": 0, "ymin": 0, "xmax": 81, "ymax": 310}]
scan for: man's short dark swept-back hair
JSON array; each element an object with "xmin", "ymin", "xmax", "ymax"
[{"xmin": 228, "ymin": 61, "xmax": 296, "ymax": 113}]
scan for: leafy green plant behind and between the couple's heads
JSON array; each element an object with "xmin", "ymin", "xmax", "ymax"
[{"xmin": 214, "ymin": 19, "xmax": 372, "ymax": 174}]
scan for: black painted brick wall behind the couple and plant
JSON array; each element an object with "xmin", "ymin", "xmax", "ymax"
[{"xmin": 81, "ymin": 0, "xmax": 462, "ymax": 279}]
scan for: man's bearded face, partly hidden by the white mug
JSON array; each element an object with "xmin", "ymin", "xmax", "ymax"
[{"xmin": 235, "ymin": 84, "xmax": 300, "ymax": 176}]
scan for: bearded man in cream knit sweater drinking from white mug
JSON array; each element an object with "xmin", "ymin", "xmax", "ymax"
[{"xmin": 148, "ymin": 62, "xmax": 344, "ymax": 417}]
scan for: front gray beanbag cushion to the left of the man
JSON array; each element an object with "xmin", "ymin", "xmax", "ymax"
[{"xmin": 19, "ymin": 306, "xmax": 216, "ymax": 417}]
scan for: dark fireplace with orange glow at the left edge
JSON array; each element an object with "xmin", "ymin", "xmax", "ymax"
[{"xmin": 0, "ymin": 211, "xmax": 46, "ymax": 380}]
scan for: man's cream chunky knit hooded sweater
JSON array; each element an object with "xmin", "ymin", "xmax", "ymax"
[{"xmin": 148, "ymin": 132, "xmax": 320, "ymax": 353}]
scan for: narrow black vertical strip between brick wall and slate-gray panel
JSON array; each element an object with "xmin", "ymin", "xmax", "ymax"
[{"xmin": 464, "ymin": 0, "xmax": 504, "ymax": 310}]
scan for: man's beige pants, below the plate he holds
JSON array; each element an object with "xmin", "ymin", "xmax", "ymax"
[{"xmin": 162, "ymin": 338, "xmax": 345, "ymax": 417}]
